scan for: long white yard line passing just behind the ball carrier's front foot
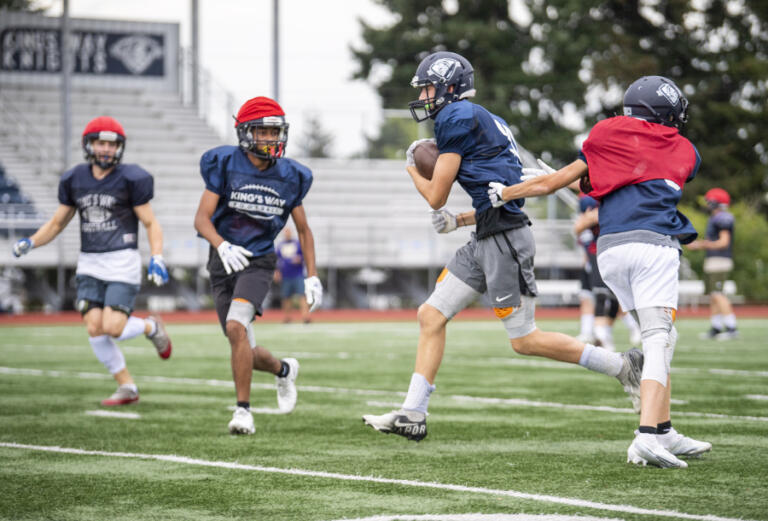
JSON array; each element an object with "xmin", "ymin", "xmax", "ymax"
[{"xmin": 0, "ymin": 367, "xmax": 768, "ymax": 422}]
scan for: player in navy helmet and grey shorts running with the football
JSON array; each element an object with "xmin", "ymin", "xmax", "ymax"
[{"xmin": 363, "ymin": 52, "xmax": 642, "ymax": 441}]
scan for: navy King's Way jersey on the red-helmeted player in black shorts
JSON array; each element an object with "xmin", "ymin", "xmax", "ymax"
[{"xmin": 200, "ymin": 146, "xmax": 312, "ymax": 257}]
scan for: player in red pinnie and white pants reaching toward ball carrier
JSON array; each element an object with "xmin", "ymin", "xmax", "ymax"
[{"xmin": 488, "ymin": 76, "xmax": 712, "ymax": 468}]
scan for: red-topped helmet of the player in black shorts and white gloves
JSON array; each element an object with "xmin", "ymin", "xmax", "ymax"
[{"xmin": 235, "ymin": 96, "xmax": 288, "ymax": 160}]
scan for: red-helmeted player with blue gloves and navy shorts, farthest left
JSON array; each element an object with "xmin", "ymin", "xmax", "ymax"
[{"xmin": 13, "ymin": 116, "xmax": 171, "ymax": 406}]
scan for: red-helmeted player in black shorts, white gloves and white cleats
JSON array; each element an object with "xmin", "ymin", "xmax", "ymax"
[{"xmin": 195, "ymin": 97, "xmax": 323, "ymax": 434}]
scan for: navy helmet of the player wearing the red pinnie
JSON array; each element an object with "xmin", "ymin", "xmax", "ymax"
[{"xmin": 624, "ymin": 76, "xmax": 688, "ymax": 129}]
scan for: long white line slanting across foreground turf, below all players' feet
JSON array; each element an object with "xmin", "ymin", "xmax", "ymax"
[{"xmin": 0, "ymin": 442, "xmax": 756, "ymax": 521}]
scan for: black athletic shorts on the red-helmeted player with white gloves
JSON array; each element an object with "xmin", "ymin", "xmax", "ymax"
[{"xmin": 207, "ymin": 247, "xmax": 277, "ymax": 329}]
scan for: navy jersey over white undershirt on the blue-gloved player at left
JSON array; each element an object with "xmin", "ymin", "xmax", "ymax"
[{"xmin": 59, "ymin": 163, "xmax": 154, "ymax": 253}]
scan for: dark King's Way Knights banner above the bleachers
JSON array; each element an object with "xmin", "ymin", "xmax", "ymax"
[{"xmin": 0, "ymin": 11, "xmax": 179, "ymax": 90}]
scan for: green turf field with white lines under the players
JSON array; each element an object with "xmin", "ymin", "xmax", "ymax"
[{"xmin": 0, "ymin": 320, "xmax": 768, "ymax": 521}]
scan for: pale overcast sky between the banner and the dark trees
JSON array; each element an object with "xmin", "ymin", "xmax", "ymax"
[{"xmin": 39, "ymin": 0, "xmax": 396, "ymax": 156}]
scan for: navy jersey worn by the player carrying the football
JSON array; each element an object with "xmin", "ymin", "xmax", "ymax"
[{"xmin": 435, "ymin": 100, "xmax": 525, "ymax": 215}]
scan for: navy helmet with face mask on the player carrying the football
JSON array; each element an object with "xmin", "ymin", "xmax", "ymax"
[{"xmin": 408, "ymin": 51, "xmax": 475, "ymax": 121}]
